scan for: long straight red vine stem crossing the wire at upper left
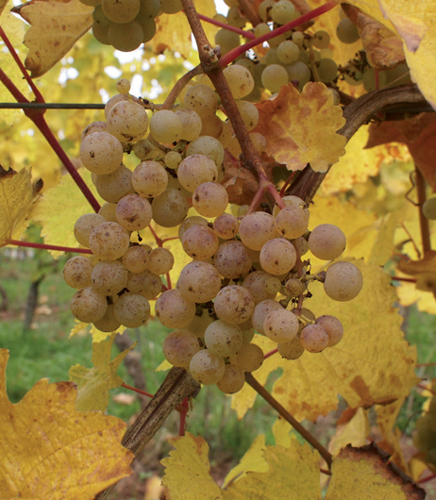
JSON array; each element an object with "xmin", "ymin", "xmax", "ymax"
[{"xmin": 0, "ymin": 68, "xmax": 100, "ymax": 212}]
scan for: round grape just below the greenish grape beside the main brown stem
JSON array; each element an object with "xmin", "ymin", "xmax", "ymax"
[{"xmin": 177, "ymin": 154, "xmax": 218, "ymax": 193}]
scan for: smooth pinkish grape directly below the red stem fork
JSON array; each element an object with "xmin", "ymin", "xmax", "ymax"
[{"xmin": 239, "ymin": 212, "xmax": 280, "ymax": 250}]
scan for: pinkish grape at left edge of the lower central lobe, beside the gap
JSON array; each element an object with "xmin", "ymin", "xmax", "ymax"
[{"xmin": 156, "ymin": 289, "xmax": 195, "ymax": 328}]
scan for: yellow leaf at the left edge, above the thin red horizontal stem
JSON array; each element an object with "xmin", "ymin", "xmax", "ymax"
[{"xmin": 0, "ymin": 165, "xmax": 42, "ymax": 246}]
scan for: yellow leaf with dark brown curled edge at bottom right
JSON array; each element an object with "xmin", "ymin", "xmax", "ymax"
[{"xmin": 325, "ymin": 445, "xmax": 425, "ymax": 500}]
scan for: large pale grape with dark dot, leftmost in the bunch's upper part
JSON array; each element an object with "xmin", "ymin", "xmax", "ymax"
[{"xmin": 80, "ymin": 132, "xmax": 123, "ymax": 175}]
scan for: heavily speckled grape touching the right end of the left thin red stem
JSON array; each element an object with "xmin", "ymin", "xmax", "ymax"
[{"xmin": 89, "ymin": 222, "xmax": 130, "ymax": 260}]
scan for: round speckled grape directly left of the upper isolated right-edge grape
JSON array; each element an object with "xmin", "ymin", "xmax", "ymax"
[{"xmin": 260, "ymin": 238, "xmax": 297, "ymax": 276}]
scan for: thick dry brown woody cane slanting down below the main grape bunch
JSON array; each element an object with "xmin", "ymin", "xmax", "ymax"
[{"xmin": 95, "ymin": 368, "xmax": 200, "ymax": 500}]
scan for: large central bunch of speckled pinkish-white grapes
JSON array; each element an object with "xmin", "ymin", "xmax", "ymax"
[{"xmin": 64, "ymin": 79, "xmax": 362, "ymax": 394}]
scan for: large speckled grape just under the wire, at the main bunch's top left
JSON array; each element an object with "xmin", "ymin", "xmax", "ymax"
[{"xmin": 107, "ymin": 99, "xmax": 148, "ymax": 142}]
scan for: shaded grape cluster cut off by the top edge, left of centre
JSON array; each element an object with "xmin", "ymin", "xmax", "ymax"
[{"xmin": 85, "ymin": 0, "xmax": 182, "ymax": 52}]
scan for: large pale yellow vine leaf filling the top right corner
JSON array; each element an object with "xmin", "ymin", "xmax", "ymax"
[{"xmin": 348, "ymin": 0, "xmax": 436, "ymax": 107}]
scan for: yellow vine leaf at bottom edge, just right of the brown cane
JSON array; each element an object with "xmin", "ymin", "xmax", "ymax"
[{"xmin": 162, "ymin": 432, "xmax": 221, "ymax": 500}]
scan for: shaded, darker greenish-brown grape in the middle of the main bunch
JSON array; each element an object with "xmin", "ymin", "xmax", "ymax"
[{"xmin": 151, "ymin": 189, "xmax": 189, "ymax": 227}]
